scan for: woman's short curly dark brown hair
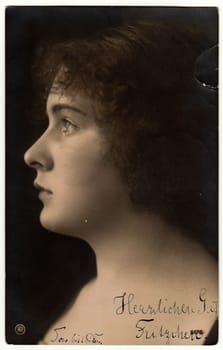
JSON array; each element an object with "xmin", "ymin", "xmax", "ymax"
[{"xmin": 34, "ymin": 20, "xmax": 217, "ymax": 227}]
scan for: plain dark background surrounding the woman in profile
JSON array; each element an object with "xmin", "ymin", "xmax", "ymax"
[{"xmin": 6, "ymin": 6, "xmax": 218, "ymax": 344}]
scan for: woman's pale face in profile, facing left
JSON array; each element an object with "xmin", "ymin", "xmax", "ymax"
[{"xmin": 25, "ymin": 81, "xmax": 129, "ymax": 236}]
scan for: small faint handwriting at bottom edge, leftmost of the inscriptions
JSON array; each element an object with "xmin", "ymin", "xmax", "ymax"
[{"xmin": 50, "ymin": 326, "xmax": 104, "ymax": 344}]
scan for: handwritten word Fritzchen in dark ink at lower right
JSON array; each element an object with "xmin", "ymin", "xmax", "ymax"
[{"xmin": 136, "ymin": 318, "xmax": 205, "ymax": 344}]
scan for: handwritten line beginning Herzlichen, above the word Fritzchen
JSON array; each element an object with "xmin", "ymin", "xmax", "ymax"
[{"xmin": 113, "ymin": 288, "xmax": 217, "ymax": 316}]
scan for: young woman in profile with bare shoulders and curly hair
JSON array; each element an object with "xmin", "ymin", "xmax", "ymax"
[{"xmin": 25, "ymin": 21, "xmax": 217, "ymax": 345}]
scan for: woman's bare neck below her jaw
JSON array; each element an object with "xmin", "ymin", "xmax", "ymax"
[{"xmin": 85, "ymin": 212, "xmax": 170, "ymax": 280}]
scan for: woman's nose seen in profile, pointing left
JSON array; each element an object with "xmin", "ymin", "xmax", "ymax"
[{"xmin": 24, "ymin": 134, "xmax": 53, "ymax": 171}]
